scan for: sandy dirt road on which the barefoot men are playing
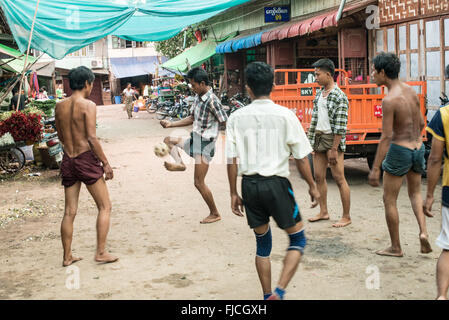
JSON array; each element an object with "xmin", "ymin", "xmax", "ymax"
[{"xmin": 0, "ymin": 105, "xmax": 441, "ymax": 300}]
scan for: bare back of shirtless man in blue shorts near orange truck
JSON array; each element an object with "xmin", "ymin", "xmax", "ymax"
[{"xmin": 384, "ymin": 83, "xmax": 424, "ymax": 149}]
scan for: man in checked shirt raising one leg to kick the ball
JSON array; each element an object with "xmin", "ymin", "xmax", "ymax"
[{"xmin": 161, "ymin": 68, "xmax": 228, "ymax": 223}]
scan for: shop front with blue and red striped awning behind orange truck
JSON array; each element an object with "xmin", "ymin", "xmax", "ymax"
[{"xmin": 216, "ymin": 0, "xmax": 377, "ymax": 94}]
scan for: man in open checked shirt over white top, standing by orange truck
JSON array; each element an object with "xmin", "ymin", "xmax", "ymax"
[{"xmin": 308, "ymin": 59, "xmax": 351, "ymax": 228}]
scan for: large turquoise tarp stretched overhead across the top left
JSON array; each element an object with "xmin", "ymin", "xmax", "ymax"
[{"xmin": 0, "ymin": 0, "xmax": 249, "ymax": 59}]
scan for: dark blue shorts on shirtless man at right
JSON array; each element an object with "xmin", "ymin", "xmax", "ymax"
[{"xmin": 382, "ymin": 143, "xmax": 426, "ymax": 177}]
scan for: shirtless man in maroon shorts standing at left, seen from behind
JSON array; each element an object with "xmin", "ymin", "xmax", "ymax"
[{"xmin": 55, "ymin": 67, "xmax": 118, "ymax": 267}]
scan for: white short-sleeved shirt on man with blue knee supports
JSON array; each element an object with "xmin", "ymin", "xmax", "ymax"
[{"xmin": 226, "ymin": 99, "xmax": 313, "ymax": 177}]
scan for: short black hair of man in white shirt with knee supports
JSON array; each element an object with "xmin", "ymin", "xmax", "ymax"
[{"xmin": 245, "ymin": 61, "xmax": 274, "ymax": 98}]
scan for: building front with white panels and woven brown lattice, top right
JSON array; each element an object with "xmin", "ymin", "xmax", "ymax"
[{"xmin": 370, "ymin": 0, "xmax": 449, "ymax": 113}]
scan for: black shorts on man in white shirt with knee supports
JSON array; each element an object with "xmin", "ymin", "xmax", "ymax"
[{"xmin": 242, "ymin": 174, "xmax": 301, "ymax": 229}]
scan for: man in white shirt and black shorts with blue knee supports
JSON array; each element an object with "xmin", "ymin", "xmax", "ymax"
[{"xmin": 226, "ymin": 62, "xmax": 320, "ymax": 300}]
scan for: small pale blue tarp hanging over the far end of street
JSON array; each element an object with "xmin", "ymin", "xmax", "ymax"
[{"xmin": 111, "ymin": 56, "xmax": 168, "ymax": 79}]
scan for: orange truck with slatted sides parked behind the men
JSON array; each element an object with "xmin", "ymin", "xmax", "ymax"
[{"xmin": 271, "ymin": 69, "xmax": 427, "ymax": 168}]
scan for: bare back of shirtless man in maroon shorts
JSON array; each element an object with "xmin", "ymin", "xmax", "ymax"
[{"xmin": 55, "ymin": 96, "xmax": 95, "ymax": 158}]
